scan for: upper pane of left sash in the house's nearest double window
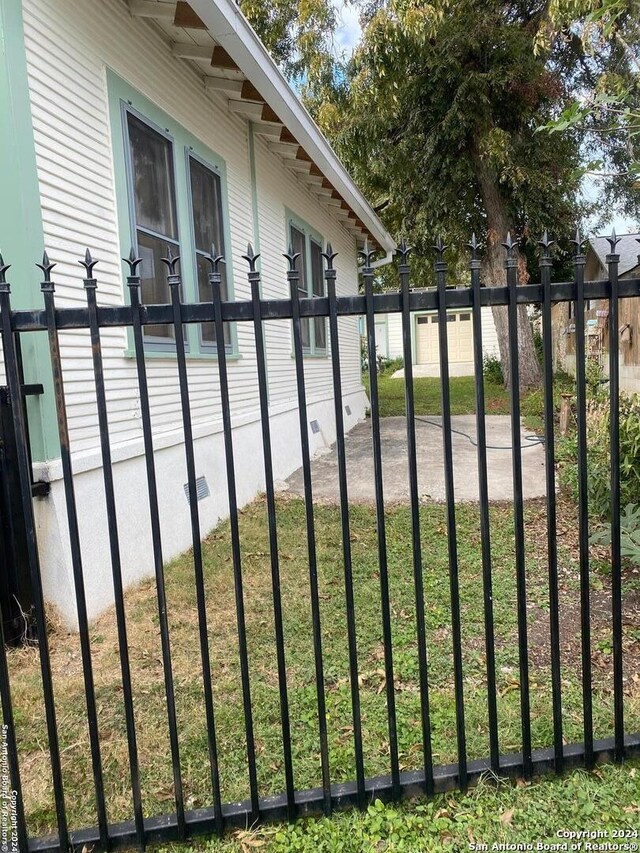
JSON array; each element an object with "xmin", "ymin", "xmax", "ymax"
[{"xmin": 128, "ymin": 113, "xmax": 178, "ymax": 240}]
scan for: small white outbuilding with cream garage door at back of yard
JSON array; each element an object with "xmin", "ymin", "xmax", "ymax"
[{"xmin": 376, "ymin": 307, "xmax": 500, "ymax": 376}]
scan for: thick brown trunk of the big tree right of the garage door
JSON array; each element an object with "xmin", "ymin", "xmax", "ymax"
[{"xmin": 474, "ymin": 152, "xmax": 541, "ymax": 391}]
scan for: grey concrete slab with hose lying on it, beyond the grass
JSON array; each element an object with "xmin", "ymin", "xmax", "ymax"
[{"xmin": 283, "ymin": 415, "xmax": 545, "ymax": 503}]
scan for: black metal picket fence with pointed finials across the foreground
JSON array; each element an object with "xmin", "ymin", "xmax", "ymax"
[{"xmin": 0, "ymin": 235, "xmax": 640, "ymax": 851}]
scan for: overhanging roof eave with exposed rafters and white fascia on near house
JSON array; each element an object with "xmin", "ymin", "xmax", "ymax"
[{"xmin": 128, "ymin": 0, "xmax": 395, "ymax": 252}]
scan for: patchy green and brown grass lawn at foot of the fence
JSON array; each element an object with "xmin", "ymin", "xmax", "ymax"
[{"xmin": 9, "ymin": 492, "xmax": 640, "ymax": 851}]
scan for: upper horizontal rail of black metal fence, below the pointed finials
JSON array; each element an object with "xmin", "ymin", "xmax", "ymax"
[{"xmin": 1, "ymin": 278, "xmax": 640, "ymax": 332}]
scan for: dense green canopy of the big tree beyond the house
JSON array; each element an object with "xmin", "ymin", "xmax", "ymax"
[{"xmin": 317, "ymin": 0, "xmax": 596, "ymax": 274}]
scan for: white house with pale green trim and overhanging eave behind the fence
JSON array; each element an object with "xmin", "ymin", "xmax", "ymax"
[{"xmin": 0, "ymin": 0, "xmax": 396, "ymax": 624}]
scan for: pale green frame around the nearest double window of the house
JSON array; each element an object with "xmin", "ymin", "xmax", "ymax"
[{"xmin": 106, "ymin": 68, "xmax": 242, "ymax": 360}]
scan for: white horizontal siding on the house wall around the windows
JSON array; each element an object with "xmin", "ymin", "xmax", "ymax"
[{"xmin": 23, "ymin": 0, "xmax": 360, "ymax": 460}]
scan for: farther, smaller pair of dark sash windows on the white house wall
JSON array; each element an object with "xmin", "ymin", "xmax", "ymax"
[{"xmin": 289, "ymin": 222, "xmax": 327, "ymax": 355}]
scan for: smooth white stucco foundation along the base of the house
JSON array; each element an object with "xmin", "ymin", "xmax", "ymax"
[{"xmin": 35, "ymin": 389, "xmax": 368, "ymax": 629}]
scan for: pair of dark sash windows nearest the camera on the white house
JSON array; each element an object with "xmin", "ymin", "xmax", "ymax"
[{"xmin": 122, "ymin": 103, "xmax": 234, "ymax": 353}]
